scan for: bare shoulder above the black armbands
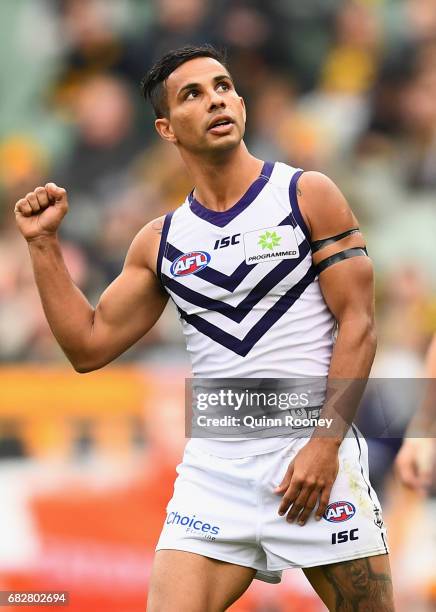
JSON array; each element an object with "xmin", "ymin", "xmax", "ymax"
[{"xmin": 297, "ymin": 171, "xmax": 358, "ymax": 240}]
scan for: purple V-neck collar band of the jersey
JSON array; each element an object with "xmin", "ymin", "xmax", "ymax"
[{"xmin": 188, "ymin": 162, "xmax": 274, "ymax": 227}]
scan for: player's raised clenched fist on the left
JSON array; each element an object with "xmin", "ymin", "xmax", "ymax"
[{"xmin": 14, "ymin": 183, "xmax": 68, "ymax": 240}]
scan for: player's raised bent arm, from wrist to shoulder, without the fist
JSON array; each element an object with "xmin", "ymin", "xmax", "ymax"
[{"xmin": 29, "ymin": 221, "xmax": 167, "ymax": 372}]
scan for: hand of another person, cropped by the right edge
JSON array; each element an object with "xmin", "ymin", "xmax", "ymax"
[{"xmin": 395, "ymin": 438, "xmax": 435, "ymax": 493}]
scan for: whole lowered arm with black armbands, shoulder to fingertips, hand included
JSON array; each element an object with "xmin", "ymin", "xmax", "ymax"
[{"xmin": 276, "ymin": 172, "xmax": 376, "ymax": 525}]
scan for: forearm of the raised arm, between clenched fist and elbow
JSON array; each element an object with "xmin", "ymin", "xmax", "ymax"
[{"xmin": 28, "ymin": 235, "xmax": 94, "ymax": 367}]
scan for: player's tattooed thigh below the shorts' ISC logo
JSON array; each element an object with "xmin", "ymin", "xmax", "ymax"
[{"xmin": 303, "ymin": 555, "xmax": 394, "ymax": 612}]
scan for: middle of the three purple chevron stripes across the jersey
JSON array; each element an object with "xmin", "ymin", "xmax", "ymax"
[{"xmin": 162, "ymin": 242, "xmax": 310, "ymax": 323}]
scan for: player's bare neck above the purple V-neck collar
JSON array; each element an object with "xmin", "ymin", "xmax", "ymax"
[{"xmin": 181, "ymin": 142, "xmax": 263, "ymax": 212}]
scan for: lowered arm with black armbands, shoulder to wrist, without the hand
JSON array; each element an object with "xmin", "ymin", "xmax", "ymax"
[{"xmin": 298, "ymin": 172, "xmax": 377, "ymax": 444}]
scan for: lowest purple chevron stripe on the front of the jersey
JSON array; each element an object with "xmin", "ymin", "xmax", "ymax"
[{"xmin": 177, "ymin": 265, "xmax": 316, "ymax": 357}]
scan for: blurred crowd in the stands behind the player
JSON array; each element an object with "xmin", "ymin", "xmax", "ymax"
[{"xmin": 0, "ymin": 0, "xmax": 436, "ymax": 366}]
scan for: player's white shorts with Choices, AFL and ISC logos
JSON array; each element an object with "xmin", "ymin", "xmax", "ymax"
[{"xmin": 156, "ymin": 428, "xmax": 388, "ymax": 583}]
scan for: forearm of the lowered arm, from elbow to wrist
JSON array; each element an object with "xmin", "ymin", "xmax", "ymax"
[{"xmin": 313, "ymin": 320, "xmax": 377, "ymax": 445}]
